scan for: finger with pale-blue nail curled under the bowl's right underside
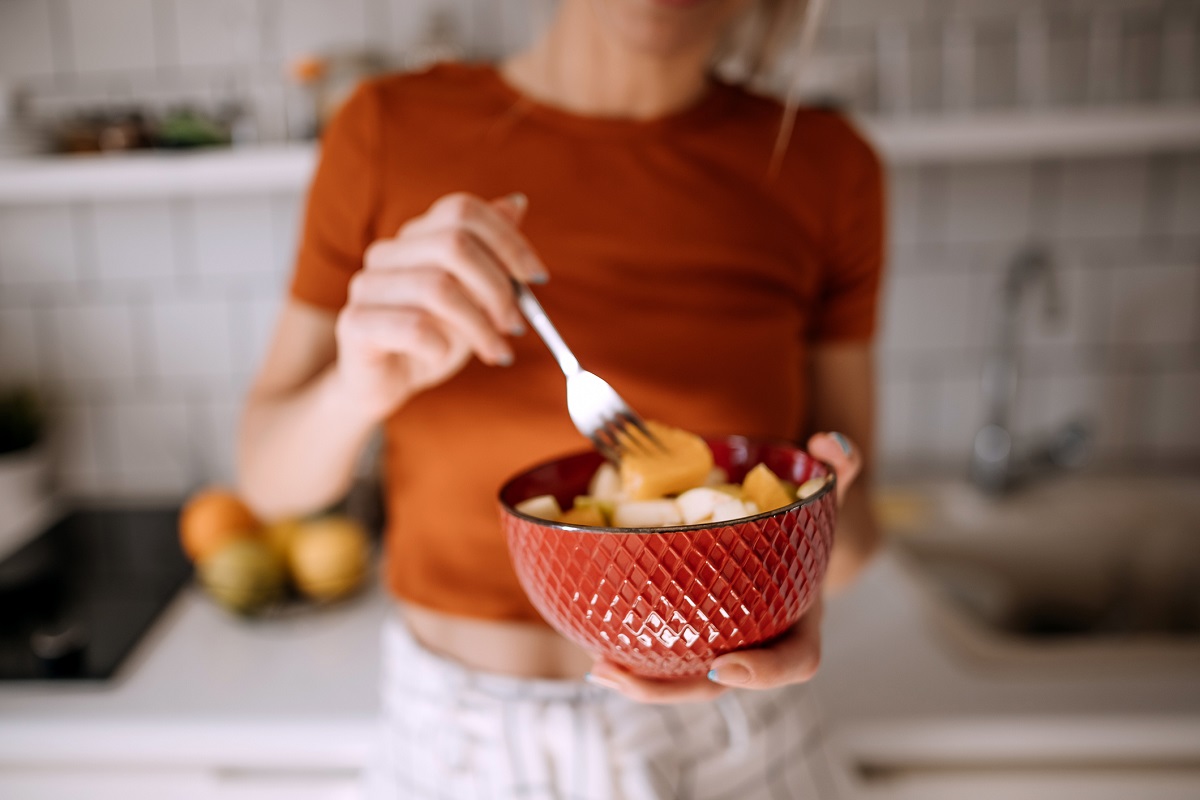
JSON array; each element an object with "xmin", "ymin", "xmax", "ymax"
[{"xmin": 708, "ymin": 599, "xmax": 823, "ymax": 688}]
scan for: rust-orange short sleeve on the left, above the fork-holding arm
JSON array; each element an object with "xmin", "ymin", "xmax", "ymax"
[{"xmin": 290, "ymin": 83, "xmax": 382, "ymax": 311}]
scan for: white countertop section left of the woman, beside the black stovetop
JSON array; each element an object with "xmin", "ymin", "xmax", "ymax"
[{"xmin": 0, "ymin": 585, "xmax": 388, "ymax": 770}]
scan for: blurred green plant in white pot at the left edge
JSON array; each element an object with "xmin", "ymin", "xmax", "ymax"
[{"xmin": 0, "ymin": 389, "xmax": 49, "ymax": 557}]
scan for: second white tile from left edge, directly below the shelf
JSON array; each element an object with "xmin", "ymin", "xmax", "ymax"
[{"xmin": 90, "ymin": 200, "xmax": 176, "ymax": 281}]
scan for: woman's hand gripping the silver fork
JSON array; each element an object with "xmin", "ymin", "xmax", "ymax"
[{"xmin": 336, "ymin": 194, "xmax": 548, "ymax": 420}]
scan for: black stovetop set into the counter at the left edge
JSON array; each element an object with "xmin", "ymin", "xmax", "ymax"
[{"xmin": 0, "ymin": 507, "xmax": 191, "ymax": 680}]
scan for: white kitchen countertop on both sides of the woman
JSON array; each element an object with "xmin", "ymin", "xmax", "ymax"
[{"xmin": 0, "ymin": 555, "xmax": 1200, "ymax": 769}]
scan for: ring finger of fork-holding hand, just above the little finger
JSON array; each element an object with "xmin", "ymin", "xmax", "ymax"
[{"xmin": 350, "ymin": 269, "xmax": 512, "ymax": 366}]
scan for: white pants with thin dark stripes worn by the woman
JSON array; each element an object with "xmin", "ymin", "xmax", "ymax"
[{"xmin": 367, "ymin": 615, "xmax": 833, "ymax": 800}]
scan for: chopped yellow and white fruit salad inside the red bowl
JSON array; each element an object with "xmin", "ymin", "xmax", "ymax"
[{"xmin": 515, "ymin": 421, "xmax": 829, "ymax": 528}]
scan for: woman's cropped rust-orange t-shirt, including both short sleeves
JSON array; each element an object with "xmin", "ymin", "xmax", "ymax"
[{"xmin": 292, "ymin": 65, "xmax": 883, "ymax": 620}]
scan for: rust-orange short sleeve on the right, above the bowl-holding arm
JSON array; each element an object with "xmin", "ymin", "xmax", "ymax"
[{"xmin": 810, "ymin": 132, "xmax": 886, "ymax": 342}]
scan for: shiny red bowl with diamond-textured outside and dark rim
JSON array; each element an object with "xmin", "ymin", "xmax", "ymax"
[{"xmin": 500, "ymin": 437, "xmax": 836, "ymax": 678}]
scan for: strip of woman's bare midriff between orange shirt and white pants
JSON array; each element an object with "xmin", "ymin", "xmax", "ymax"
[{"xmin": 400, "ymin": 602, "xmax": 592, "ymax": 679}]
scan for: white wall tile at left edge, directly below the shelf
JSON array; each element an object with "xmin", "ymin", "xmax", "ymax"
[{"xmin": 0, "ymin": 205, "xmax": 82, "ymax": 287}]
